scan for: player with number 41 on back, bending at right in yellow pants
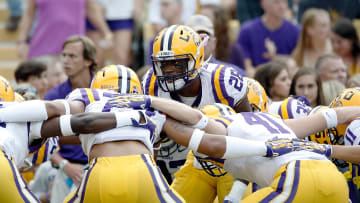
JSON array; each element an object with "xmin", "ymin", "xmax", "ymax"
[{"xmin": 138, "ymin": 94, "xmax": 360, "ymax": 202}]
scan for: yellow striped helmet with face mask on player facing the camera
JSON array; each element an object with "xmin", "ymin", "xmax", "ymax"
[{"xmin": 151, "ymin": 25, "xmax": 207, "ymax": 92}]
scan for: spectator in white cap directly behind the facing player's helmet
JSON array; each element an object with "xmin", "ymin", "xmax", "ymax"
[{"xmin": 186, "ymin": 15, "xmax": 245, "ymax": 75}]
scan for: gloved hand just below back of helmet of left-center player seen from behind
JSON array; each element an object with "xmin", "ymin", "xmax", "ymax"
[{"xmin": 109, "ymin": 94, "xmax": 151, "ymax": 109}]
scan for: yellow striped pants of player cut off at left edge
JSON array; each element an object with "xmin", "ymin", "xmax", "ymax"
[{"xmin": 0, "ymin": 150, "xmax": 39, "ymax": 202}]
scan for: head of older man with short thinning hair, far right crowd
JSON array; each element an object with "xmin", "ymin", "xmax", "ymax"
[{"xmin": 315, "ymin": 54, "xmax": 346, "ymax": 85}]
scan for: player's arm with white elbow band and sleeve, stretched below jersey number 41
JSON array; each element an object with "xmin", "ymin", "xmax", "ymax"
[{"xmin": 163, "ymin": 118, "xmax": 290, "ymax": 159}]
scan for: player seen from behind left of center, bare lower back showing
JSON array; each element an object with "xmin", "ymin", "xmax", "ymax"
[{"xmin": 1, "ymin": 65, "xmax": 183, "ymax": 202}]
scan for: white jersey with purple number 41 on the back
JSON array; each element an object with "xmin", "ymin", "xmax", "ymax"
[{"xmin": 224, "ymin": 112, "xmax": 328, "ymax": 187}]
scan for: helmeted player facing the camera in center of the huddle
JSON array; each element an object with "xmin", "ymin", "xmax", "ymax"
[{"xmin": 143, "ymin": 25, "xmax": 251, "ymax": 202}]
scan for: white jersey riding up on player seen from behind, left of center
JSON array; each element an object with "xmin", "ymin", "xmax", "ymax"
[{"xmin": 67, "ymin": 88, "xmax": 166, "ymax": 155}]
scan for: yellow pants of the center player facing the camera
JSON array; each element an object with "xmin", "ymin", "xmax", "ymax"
[{"xmin": 171, "ymin": 152, "xmax": 234, "ymax": 203}]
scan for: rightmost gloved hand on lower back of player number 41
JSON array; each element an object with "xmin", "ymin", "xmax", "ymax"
[{"xmin": 292, "ymin": 139, "xmax": 332, "ymax": 157}]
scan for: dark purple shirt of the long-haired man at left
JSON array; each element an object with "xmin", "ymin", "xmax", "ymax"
[{"xmin": 44, "ymin": 75, "xmax": 94, "ymax": 164}]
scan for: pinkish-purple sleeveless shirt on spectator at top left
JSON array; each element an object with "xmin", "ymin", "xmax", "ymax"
[{"xmin": 28, "ymin": 0, "xmax": 86, "ymax": 58}]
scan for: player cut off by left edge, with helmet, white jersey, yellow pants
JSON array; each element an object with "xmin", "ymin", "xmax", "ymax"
[{"xmin": 0, "ymin": 76, "xmax": 57, "ymax": 202}]
